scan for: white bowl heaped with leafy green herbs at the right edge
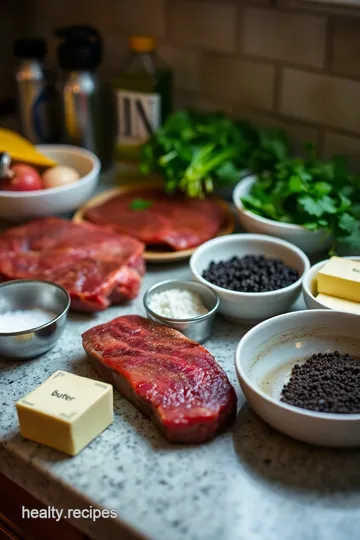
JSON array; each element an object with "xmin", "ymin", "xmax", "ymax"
[{"xmin": 234, "ymin": 145, "xmax": 360, "ymax": 252}]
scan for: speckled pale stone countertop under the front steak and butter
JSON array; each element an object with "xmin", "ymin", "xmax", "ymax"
[{"xmin": 0, "ymin": 264, "xmax": 360, "ymax": 540}]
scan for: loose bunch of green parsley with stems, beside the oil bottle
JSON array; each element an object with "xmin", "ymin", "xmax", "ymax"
[{"xmin": 140, "ymin": 111, "xmax": 288, "ymax": 197}]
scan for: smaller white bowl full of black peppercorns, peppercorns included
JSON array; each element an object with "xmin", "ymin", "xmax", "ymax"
[{"xmin": 190, "ymin": 234, "xmax": 310, "ymax": 324}]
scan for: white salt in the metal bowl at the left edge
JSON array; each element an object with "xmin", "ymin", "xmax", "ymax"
[{"xmin": 0, "ymin": 308, "xmax": 56, "ymax": 334}]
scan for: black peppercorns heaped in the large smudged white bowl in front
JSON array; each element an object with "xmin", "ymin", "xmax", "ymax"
[{"xmin": 280, "ymin": 351, "xmax": 360, "ymax": 414}]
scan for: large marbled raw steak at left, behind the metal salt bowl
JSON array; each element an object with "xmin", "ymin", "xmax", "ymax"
[{"xmin": 0, "ymin": 218, "xmax": 145, "ymax": 311}]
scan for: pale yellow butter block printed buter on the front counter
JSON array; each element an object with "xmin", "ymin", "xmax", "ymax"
[{"xmin": 16, "ymin": 371, "xmax": 114, "ymax": 456}]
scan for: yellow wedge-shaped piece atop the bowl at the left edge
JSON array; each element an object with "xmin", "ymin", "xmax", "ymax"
[{"xmin": 0, "ymin": 128, "xmax": 57, "ymax": 167}]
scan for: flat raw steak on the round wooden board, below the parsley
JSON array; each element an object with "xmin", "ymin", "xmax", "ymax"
[{"xmin": 85, "ymin": 189, "xmax": 224, "ymax": 251}]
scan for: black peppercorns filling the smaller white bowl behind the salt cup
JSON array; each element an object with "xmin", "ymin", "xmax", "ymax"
[{"xmin": 202, "ymin": 255, "xmax": 299, "ymax": 292}]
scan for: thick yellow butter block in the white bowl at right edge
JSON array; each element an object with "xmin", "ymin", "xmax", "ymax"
[{"xmin": 317, "ymin": 257, "xmax": 360, "ymax": 302}]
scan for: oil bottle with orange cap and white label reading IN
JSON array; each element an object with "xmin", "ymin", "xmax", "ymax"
[{"xmin": 113, "ymin": 36, "xmax": 172, "ymax": 165}]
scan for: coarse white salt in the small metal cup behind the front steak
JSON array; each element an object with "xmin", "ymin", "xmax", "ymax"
[{"xmin": 149, "ymin": 289, "xmax": 209, "ymax": 319}]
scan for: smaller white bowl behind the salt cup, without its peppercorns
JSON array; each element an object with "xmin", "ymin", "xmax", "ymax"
[{"xmin": 190, "ymin": 234, "xmax": 310, "ymax": 324}]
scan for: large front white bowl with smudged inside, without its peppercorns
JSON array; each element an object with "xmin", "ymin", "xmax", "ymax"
[{"xmin": 235, "ymin": 310, "xmax": 360, "ymax": 447}]
